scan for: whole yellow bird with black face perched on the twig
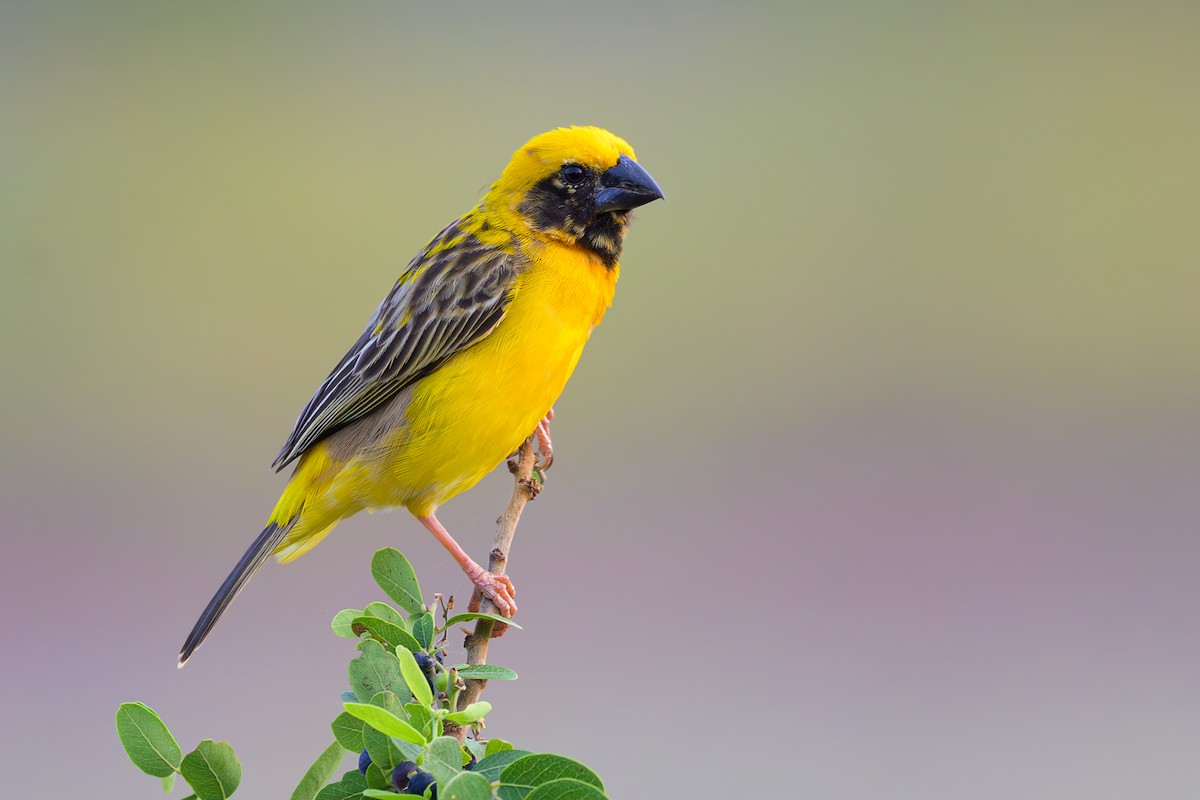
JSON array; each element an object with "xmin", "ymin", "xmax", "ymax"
[{"xmin": 179, "ymin": 127, "xmax": 662, "ymax": 667}]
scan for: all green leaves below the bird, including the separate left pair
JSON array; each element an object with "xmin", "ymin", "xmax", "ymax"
[{"xmin": 116, "ymin": 548, "xmax": 605, "ymax": 800}]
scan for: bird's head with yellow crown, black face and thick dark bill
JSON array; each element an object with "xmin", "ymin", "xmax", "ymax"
[{"xmin": 485, "ymin": 127, "xmax": 662, "ymax": 266}]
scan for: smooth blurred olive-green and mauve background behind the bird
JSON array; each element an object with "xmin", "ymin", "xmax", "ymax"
[{"xmin": 0, "ymin": 0, "xmax": 1200, "ymax": 799}]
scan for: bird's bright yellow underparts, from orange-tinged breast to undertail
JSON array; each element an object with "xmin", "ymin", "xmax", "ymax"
[{"xmin": 271, "ymin": 237, "xmax": 618, "ymax": 560}]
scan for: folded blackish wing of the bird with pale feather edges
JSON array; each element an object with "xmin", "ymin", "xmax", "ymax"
[{"xmin": 274, "ymin": 215, "xmax": 517, "ymax": 469}]
